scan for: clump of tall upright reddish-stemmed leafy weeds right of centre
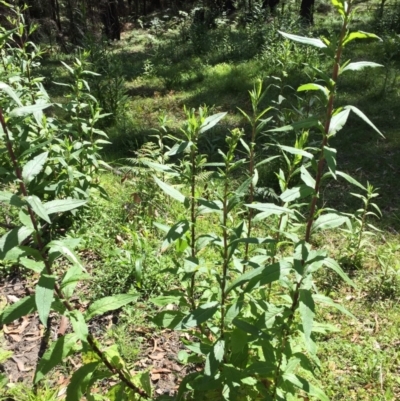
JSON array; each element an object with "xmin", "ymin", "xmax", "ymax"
[{"xmin": 153, "ymin": 0, "xmax": 380, "ymax": 401}]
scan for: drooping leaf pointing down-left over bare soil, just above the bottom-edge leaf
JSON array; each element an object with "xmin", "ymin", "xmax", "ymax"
[{"xmin": 33, "ymin": 333, "xmax": 79, "ymax": 384}]
